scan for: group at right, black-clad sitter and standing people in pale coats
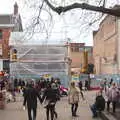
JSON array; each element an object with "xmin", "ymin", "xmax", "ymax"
[{"xmin": 91, "ymin": 78, "xmax": 120, "ymax": 117}]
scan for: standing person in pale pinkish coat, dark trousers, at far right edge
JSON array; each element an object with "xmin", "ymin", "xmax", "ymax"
[{"xmin": 106, "ymin": 82, "xmax": 120, "ymax": 113}]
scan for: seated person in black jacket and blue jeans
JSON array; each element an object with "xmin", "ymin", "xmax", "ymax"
[{"xmin": 90, "ymin": 91, "xmax": 105, "ymax": 117}]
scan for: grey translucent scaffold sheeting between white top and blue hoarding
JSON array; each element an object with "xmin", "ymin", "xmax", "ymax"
[{"xmin": 10, "ymin": 45, "xmax": 68, "ymax": 77}]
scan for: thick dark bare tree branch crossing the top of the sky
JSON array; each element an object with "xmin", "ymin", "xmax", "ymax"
[{"xmin": 44, "ymin": 0, "xmax": 120, "ymax": 17}]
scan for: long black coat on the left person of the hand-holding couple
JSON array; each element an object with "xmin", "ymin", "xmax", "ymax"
[{"xmin": 23, "ymin": 87, "xmax": 41, "ymax": 109}]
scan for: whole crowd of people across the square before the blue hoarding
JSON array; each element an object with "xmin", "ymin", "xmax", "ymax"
[{"xmin": 1, "ymin": 78, "xmax": 120, "ymax": 120}]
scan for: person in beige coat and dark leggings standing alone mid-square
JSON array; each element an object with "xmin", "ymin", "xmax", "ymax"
[{"xmin": 68, "ymin": 82, "xmax": 84, "ymax": 117}]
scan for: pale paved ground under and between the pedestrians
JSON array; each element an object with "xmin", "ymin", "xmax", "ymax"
[{"xmin": 0, "ymin": 91, "xmax": 111, "ymax": 120}]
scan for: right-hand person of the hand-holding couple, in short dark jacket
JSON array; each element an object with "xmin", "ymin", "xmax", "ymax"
[{"xmin": 42, "ymin": 83, "xmax": 60, "ymax": 120}]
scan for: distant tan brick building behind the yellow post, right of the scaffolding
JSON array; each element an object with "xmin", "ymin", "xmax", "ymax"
[{"xmin": 69, "ymin": 43, "xmax": 94, "ymax": 72}]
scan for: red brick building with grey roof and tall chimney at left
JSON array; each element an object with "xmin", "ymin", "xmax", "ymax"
[{"xmin": 0, "ymin": 3, "xmax": 23, "ymax": 71}]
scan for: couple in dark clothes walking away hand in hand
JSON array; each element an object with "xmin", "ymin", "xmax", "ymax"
[{"xmin": 23, "ymin": 78, "xmax": 60, "ymax": 120}]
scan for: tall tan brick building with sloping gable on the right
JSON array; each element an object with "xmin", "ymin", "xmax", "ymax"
[{"xmin": 93, "ymin": 15, "xmax": 120, "ymax": 74}]
